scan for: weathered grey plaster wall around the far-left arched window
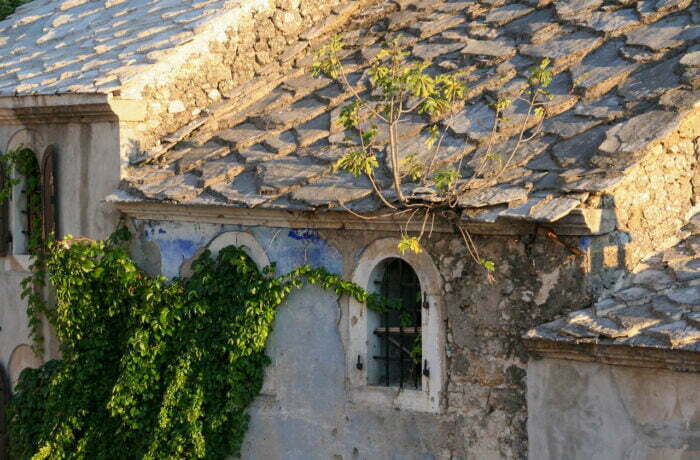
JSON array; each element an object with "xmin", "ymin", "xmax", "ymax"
[{"xmin": 0, "ymin": 118, "xmax": 119, "ymax": 381}]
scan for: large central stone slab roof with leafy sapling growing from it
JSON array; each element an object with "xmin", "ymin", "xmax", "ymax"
[{"xmin": 106, "ymin": 0, "xmax": 700, "ymax": 222}]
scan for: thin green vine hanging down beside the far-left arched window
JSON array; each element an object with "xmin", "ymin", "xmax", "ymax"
[{"xmin": 0, "ymin": 148, "xmax": 50, "ymax": 354}]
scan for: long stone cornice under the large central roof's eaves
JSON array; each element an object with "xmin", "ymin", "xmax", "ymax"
[{"xmin": 114, "ymin": 200, "xmax": 615, "ymax": 236}]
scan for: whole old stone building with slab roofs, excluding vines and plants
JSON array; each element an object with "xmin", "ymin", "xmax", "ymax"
[{"xmin": 0, "ymin": 0, "xmax": 700, "ymax": 459}]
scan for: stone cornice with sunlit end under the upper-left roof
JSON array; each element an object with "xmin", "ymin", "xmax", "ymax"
[{"xmin": 0, "ymin": 94, "xmax": 146, "ymax": 125}]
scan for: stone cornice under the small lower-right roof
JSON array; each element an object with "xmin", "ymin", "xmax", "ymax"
[{"xmin": 525, "ymin": 339, "xmax": 700, "ymax": 372}]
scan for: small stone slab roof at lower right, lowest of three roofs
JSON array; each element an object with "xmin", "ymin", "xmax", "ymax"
[{"xmin": 525, "ymin": 214, "xmax": 700, "ymax": 352}]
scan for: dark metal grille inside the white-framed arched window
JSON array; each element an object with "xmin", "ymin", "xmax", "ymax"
[{"xmin": 373, "ymin": 259, "xmax": 423, "ymax": 389}]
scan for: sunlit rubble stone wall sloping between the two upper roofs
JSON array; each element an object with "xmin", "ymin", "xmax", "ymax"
[{"xmin": 129, "ymin": 0, "xmax": 386, "ymax": 153}]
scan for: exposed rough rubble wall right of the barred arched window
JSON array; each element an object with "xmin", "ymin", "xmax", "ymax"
[{"xmin": 431, "ymin": 232, "xmax": 592, "ymax": 459}]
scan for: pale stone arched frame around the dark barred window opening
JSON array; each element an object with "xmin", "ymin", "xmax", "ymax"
[{"xmin": 346, "ymin": 238, "xmax": 446, "ymax": 412}]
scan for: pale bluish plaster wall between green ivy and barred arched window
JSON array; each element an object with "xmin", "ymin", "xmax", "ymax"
[{"xmin": 242, "ymin": 287, "xmax": 454, "ymax": 460}]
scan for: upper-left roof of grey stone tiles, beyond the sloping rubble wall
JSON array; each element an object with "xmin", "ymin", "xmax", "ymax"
[{"xmin": 0, "ymin": 0, "xmax": 262, "ymax": 96}]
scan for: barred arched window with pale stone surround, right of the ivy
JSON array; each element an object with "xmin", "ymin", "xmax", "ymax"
[{"xmin": 345, "ymin": 238, "xmax": 446, "ymax": 412}]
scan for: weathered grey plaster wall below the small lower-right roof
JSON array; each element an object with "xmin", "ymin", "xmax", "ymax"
[{"xmin": 527, "ymin": 359, "xmax": 700, "ymax": 460}]
